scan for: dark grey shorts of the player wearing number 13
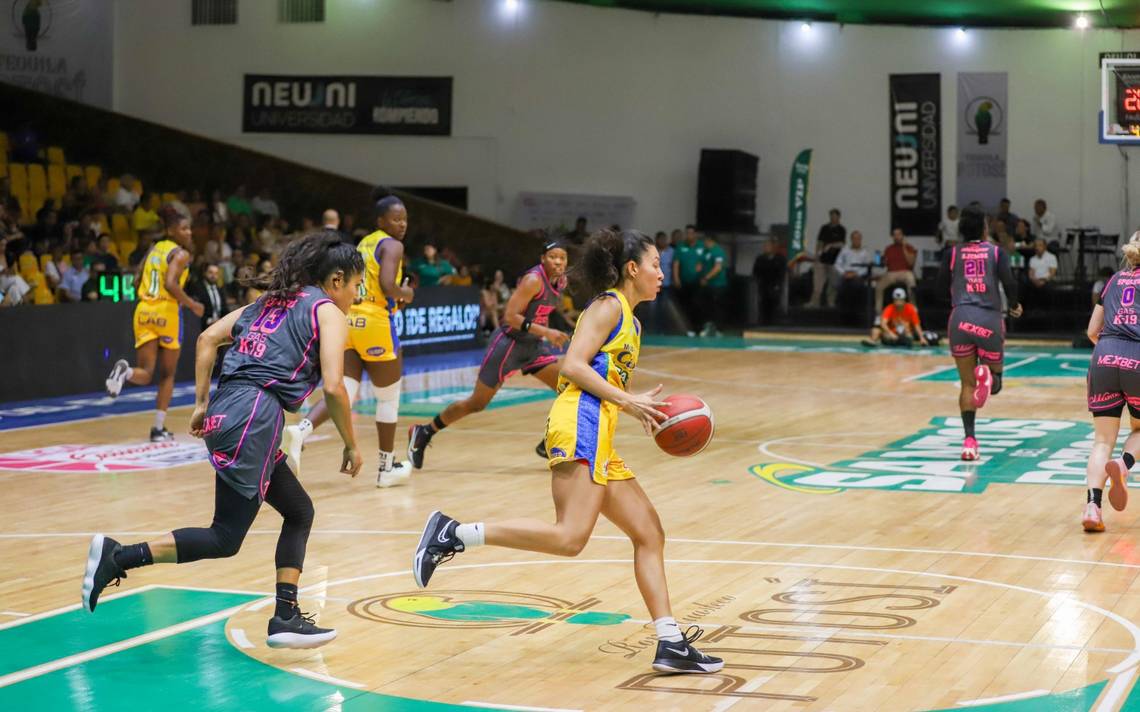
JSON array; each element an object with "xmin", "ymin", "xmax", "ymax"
[{"xmin": 204, "ymin": 384, "xmax": 285, "ymax": 499}]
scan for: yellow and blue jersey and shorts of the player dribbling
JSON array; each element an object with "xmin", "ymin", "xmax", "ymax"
[{"xmin": 546, "ymin": 289, "xmax": 641, "ymax": 485}]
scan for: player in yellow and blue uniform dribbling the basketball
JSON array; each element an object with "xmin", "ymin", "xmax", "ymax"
[{"xmin": 413, "ymin": 230, "xmax": 724, "ymax": 672}]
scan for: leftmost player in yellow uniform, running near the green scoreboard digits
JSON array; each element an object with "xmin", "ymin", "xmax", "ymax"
[{"xmin": 106, "ymin": 212, "xmax": 205, "ymax": 442}]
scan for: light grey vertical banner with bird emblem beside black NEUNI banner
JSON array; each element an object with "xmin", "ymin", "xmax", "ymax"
[{"xmin": 958, "ymin": 72, "xmax": 1009, "ymax": 212}]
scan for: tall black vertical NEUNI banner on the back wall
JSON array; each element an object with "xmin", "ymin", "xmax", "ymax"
[{"xmin": 890, "ymin": 74, "xmax": 942, "ymax": 235}]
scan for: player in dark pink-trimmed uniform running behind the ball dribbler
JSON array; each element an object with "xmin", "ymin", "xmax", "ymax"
[{"xmin": 408, "ymin": 240, "xmax": 570, "ymax": 469}]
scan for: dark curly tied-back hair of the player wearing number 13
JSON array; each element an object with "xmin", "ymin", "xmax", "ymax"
[{"xmin": 250, "ymin": 230, "xmax": 364, "ymax": 296}]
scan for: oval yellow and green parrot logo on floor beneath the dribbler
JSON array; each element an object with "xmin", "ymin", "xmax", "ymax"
[{"xmin": 349, "ymin": 590, "xmax": 629, "ymax": 636}]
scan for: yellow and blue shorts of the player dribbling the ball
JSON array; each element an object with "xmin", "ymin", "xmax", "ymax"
[{"xmin": 546, "ymin": 388, "xmax": 634, "ymax": 485}]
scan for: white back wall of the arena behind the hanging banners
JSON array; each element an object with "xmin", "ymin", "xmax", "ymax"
[{"xmin": 114, "ymin": 0, "xmax": 1140, "ymax": 247}]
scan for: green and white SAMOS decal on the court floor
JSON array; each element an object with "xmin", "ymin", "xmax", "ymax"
[{"xmin": 749, "ymin": 417, "xmax": 1092, "ymax": 494}]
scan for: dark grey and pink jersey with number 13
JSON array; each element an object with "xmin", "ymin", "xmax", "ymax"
[{"xmin": 219, "ymin": 287, "xmax": 332, "ymax": 412}]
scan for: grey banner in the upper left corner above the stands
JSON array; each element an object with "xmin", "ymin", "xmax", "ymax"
[{"xmin": 0, "ymin": 0, "xmax": 114, "ymax": 109}]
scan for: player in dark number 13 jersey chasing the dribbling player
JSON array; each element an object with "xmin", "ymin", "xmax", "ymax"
[{"xmin": 82, "ymin": 231, "xmax": 364, "ymax": 648}]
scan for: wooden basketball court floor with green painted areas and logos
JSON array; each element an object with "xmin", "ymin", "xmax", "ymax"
[{"xmin": 0, "ymin": 341, "xmax": 1140, "ymax": 712}]
